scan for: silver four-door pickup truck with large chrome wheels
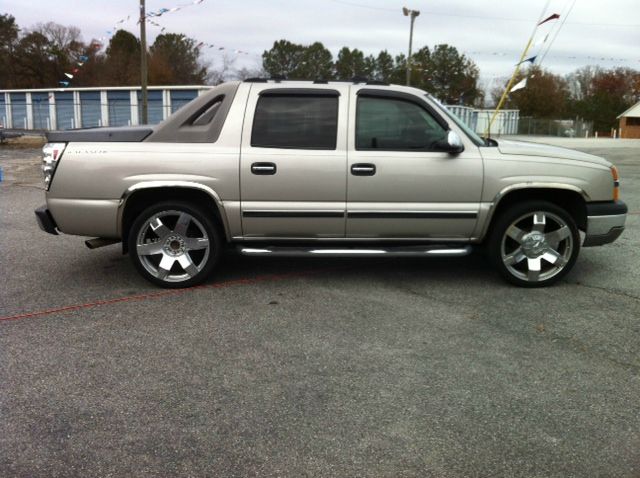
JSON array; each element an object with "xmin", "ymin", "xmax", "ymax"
[{"xmin": 36, "ymin": 79, "xmax": 627, "ymax": 287}]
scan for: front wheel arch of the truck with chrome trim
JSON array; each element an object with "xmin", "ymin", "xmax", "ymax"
[{"xmin": 481, "ymin": 184, "xmax": 589, "ymax": 240}]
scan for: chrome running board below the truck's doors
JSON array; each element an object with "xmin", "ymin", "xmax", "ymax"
[{"xmin": 238, "ymin": 245, "xmax": 472, "ymax": 257}]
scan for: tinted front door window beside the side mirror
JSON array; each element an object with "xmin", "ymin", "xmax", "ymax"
[{"xmin": 356, "ymin": 96, "xmax": 446, "ymax": 151}]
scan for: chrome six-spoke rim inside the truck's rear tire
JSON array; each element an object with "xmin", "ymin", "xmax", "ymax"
[{"xmin": 136, "ymin": 210, "xmax": 210, "ymax": 282}]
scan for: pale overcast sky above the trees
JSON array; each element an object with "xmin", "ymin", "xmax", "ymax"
[{"xmin": 5, "ymin": 0, "xmax": 640, "ymax": 81}]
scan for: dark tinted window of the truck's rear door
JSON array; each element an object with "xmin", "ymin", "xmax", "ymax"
[{"xmin": 251, "ymin": 96, "xmax": 338, "ymax": 149}]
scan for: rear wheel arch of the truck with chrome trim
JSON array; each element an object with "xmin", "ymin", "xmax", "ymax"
[{"xmin": 117, "ymin": 181, "xmax": 231, "ymax": 254}]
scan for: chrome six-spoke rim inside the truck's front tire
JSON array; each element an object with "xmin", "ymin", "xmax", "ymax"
[{"xmin": 500, "ymin": 211, "xmax": 574, "ymax": 282}]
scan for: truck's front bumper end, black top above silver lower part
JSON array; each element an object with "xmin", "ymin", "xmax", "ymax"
[{"xmin": 582, "ymin": 201, "xmax": 628, "ymax": 247}]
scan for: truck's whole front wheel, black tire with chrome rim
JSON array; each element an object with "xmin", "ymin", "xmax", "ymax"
[{"xmin": 487, "ymin": 201, "xmax": 580, "ymax": 287}]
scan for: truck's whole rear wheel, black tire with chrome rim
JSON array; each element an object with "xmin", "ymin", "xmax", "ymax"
[{"xmin": 128, "ymin": 201, "xmax": 222, "ymax": 289}]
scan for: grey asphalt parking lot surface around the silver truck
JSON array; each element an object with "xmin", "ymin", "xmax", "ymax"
[{"xmin": 0, "ymin": 139, "xmax": 640, "ymax": 477}]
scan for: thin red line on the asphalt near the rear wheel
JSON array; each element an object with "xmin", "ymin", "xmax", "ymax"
[{"xmin": 0, "ymin": 267, "xmax": 346, "ymax": 322}]
